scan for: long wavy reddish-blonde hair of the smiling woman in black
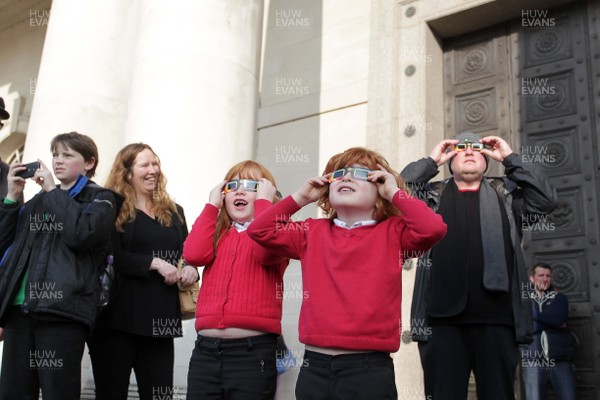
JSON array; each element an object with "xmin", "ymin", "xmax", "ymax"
[{"xmin": 105, "ymin": 143, "xmax": 183, "ymax": 232}]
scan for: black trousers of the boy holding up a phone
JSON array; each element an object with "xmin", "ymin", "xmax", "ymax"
[{"xmin": 0, "ymin": 306, "xmax": 87, "ymax": 400}]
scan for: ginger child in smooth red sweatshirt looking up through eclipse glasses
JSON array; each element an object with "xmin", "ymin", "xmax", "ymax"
[{"xmin": 248, "ymin": 148, "xmax": 446, "ymax": 400}]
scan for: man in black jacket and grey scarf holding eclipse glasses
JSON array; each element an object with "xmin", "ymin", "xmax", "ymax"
[{"xmin": 401, "ymin": 132, "xmax": 556, "ymax": 400}]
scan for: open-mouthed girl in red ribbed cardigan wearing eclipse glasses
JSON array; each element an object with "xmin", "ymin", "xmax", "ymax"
[{"xmin": 183, "ymin": 161, "xmax": 289, "ymax": 400}]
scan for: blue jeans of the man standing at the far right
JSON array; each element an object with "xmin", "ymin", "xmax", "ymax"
[{"xmin": 521, "ymin": 358, "xmax": 576, "ymax": 400}]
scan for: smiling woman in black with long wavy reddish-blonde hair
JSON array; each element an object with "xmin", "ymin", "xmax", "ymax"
[{"xmin": 89, "ymin": 143, "xmax": 198, "ymax": 400}]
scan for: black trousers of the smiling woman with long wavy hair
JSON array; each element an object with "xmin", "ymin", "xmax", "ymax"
[{"xmin": 88, "ymin": 328, "xmax": 177, "ymax": 400}]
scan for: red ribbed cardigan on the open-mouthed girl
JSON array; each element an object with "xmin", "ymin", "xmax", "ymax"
[{"xmin": 183, "ymin": 201, "xmax": 288, "ymax": 335}]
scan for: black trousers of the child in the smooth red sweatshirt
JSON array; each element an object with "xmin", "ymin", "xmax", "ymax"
[{"xmin": 296, "ymin": 350, "xmax": 398, "ymax": 400}]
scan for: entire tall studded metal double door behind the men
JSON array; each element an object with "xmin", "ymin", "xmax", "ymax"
[{"xmin": 444, "ymin": 1, "xmax": 600, "ymax": 399}]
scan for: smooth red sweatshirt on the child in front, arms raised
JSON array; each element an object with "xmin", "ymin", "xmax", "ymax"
[{"xmin": 248, "ymin": 191, "xmax": 446, "ymax": 352}]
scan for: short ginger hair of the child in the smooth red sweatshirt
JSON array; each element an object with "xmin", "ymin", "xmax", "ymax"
[{"xmin": 317, "ymin": 147, "xmax": 405, "ymax": 221}]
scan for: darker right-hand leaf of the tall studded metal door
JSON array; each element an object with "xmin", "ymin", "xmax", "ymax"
[{"xmin": 518, "ymin": 3, "xmax": 600, "ymax": 399}]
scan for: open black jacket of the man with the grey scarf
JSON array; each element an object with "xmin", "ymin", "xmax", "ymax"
[{"xmin": 401, "ymin": 153, "xmax": 556, "ymax": 343}]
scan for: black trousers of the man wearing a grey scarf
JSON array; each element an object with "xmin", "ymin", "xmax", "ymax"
[{"xmin": 419, "ymin": 325, "xmax": 519, "ymax": 400}]
